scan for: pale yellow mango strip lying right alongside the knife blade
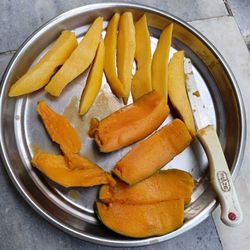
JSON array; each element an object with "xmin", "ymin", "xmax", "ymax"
[{"xmin": 168, "ymin": 51, "xmax": 196, "ymax": 137}]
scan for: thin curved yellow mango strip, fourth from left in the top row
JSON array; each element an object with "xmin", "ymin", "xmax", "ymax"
[{"xmin": 104, "ymin": 13, "xmax": 125, "ymax": 97}]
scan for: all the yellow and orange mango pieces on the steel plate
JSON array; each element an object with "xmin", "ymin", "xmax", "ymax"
[{"xmin": 9, "ymin": 12, "xmax": 196, "ymax": 237}]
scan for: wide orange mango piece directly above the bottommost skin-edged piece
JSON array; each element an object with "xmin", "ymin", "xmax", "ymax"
[{"xmin": 99, "ymin": 169, "xmax": 194, "ymax": 204}]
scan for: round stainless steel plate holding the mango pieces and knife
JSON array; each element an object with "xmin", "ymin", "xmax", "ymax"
[{"xmin": 0, "ymin": 3, "xmax": 246, "ymax": 246}]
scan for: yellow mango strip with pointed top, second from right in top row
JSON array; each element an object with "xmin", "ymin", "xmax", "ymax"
[{"xmin": 152, "ymin": 23, "xmax": 173, "ymax": 102}]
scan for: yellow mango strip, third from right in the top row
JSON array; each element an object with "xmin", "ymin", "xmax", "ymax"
[{"xmin": 131, "ymin": 15, "xmax": 152, "ymax": 101}]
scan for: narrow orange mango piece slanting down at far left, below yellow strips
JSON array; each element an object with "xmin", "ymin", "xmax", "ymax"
[{"xmin": 37, "ymin": 100, "xmax": 81, "ymax": 153}]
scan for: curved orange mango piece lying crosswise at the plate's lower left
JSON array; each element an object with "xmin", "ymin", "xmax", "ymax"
[{"xmin": 32, "ymin": 151, "xmax": 113, "ymax": 187}]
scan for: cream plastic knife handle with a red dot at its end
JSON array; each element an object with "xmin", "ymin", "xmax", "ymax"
[{"xmin": 197, "ymin": 125, "xmax": 243, "ymax": 227}]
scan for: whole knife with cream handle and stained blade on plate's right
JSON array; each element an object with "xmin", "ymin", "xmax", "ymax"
[{"xmin": 184, "ymin": 58, "xmax": 243, "ymax": 227}]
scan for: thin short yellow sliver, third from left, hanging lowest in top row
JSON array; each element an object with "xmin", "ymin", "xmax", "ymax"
[{"xmin": 79, "ymin": 40, "xmax": 105, "ymax": 115}]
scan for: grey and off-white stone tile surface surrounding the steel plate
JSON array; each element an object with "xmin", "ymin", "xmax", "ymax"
[{"xmin": 0, "ymin": 0, "xmax": 250, "ymax": 250}]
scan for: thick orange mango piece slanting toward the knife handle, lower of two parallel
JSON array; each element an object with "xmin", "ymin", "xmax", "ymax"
[{"xmin": 112, "ymin": 119, "xmax": 192, "ymax": 185}]
